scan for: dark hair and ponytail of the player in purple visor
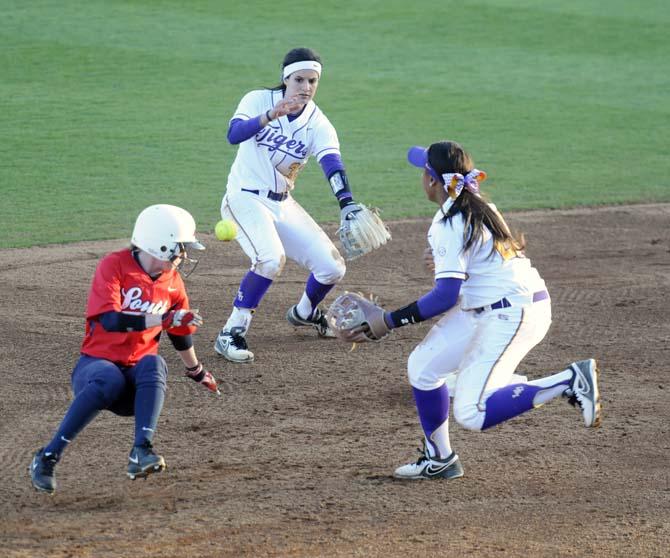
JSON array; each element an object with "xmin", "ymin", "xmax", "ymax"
[{"xmin": 428, "ymin": 141, "xmax": 526, "ymax": 259}]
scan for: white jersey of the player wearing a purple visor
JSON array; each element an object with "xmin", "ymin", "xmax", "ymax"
[{"xmin": 428, "ymin": 199, "xmax": 546, "ymax": 310}]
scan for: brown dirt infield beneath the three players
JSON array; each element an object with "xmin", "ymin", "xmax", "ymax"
[{"xmin": 0, "ymin": 204, "xmax": 670, "ymax": 558}]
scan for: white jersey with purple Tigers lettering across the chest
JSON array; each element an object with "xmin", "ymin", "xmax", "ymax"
[{"xmin": 228, "ymin": 89, "xmax": 340, "ymax": 193}]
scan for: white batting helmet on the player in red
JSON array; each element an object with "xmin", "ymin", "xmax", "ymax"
[{"xmin": 131, "ymin": 204, "xmax": 205, "ymax": 262}]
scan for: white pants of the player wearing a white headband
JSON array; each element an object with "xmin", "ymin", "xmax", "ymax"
[{"xmin": 221, "ymin": 190, "xmax": 346, "ymax": 285}]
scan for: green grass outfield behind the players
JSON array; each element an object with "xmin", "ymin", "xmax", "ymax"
[{"xmin": 0, "ymin": 0, "xmax": 670, "ymax": 247}]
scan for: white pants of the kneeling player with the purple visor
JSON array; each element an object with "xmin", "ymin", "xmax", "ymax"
[{"xmin": 407, "ymin": 300, "xmax": 551, "ymax": 430}]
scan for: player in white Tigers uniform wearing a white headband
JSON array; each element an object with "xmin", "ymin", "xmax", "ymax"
[{"xmin": 214, "ymin": 48, "xmax": 360, "ymax": 362}]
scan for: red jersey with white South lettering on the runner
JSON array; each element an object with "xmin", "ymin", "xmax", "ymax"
[{"xmin": 81, "ymin": 249, "xmax": 195, "ymax": 366}]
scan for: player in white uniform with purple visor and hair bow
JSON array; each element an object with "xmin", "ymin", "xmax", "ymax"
[{"xmin": 385, "ymin": 141, "xmax": 600, "ymax": 479}]
